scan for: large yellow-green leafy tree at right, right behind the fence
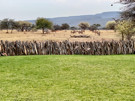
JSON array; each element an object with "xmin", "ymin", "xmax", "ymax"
[{"xmin": 116, "ymin": 20, "xmax": 135, "ymax": 40}]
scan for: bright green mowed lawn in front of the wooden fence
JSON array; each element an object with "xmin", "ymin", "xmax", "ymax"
[{"xmin": 0, "ymin": 55, "xmax": 135, "ymax": 101}]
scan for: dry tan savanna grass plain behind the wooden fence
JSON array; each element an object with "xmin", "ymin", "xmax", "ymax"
[{"xmin": 0, "ymin": 30, "xmax": 121, "ymax": 42}]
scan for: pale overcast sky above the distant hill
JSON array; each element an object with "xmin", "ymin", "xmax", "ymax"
[{"xmin": 0, "ymin": 0, "xmax": 120, "ymax": 20}]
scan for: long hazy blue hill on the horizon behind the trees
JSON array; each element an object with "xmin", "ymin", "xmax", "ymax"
[{"xmin": 29, "ymin": 11, "xmax": 120, "ymax": 27}]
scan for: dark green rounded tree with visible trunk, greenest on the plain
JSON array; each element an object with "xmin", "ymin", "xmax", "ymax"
[{"xmin": 36, "ymin": 18, "xmax": 53, "ymax": 34}]
